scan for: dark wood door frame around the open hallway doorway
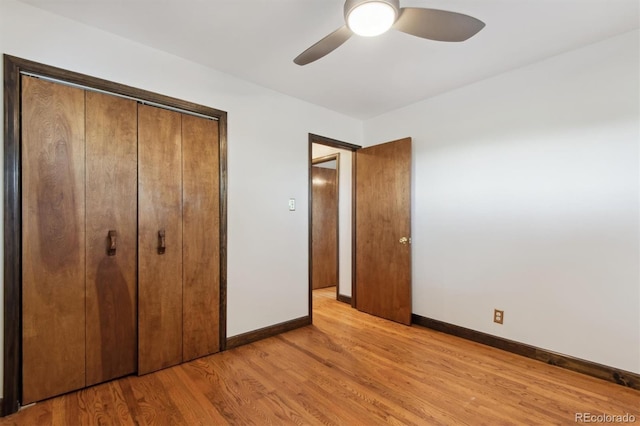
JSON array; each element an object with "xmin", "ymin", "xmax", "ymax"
[{"xmin": 307, "ymin": 133, "xmax": 362, "ymax": 322}]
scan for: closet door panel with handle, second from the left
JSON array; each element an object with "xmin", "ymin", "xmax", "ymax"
[{"xmin": 86, "ymin": 92, "xmax": 138, "ymax": 386}]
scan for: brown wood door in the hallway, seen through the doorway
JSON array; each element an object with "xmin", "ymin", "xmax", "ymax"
[{"xmin": 311, "ymin": 166, "xmax": 338, "ymax": 290}]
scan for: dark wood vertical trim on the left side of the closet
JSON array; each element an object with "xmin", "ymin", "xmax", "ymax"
[{"xmin": 0, "ymin": 55, "xmax": 22, "ymax": 416}]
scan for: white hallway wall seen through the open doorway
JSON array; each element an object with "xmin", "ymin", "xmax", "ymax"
[{"xmin": 311, "ymin": 143, "xmax": 354, "ymax": 297}]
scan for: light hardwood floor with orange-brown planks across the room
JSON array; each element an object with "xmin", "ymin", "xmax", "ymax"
[{"xmin": 0, "ymin": 287, "xmax": 640, "ymax": 425}]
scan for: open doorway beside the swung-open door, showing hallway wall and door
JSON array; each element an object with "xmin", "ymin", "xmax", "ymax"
[{"xmin": 309, "ymin": 134, "xmax": 361, "ymax": 315}]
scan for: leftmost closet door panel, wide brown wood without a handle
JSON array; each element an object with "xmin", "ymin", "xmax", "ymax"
[{"xmin": 22, "ymin": 77, "xmax": 85, "ymax": 404}]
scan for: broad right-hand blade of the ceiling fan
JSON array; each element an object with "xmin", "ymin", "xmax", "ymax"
[{"xmin": 393, "ymin": 7, "xmax": 484, "ymax": 41}]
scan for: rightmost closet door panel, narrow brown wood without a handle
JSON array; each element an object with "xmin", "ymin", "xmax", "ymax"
[{"xmin": 182, "ymin": 115, "xmax": 220, "ymax": 361}]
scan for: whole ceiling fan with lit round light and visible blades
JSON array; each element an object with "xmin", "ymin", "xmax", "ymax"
[{"xmin": 293, "ymin": 0, "xmax": 484, "ymax": 65}]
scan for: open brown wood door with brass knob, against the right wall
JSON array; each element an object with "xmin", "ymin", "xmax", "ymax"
[{"xmin": 355, "ymin": 138, "xmax": 411, "ymax": 324}]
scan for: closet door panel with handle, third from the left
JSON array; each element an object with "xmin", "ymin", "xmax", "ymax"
[{"xmin": 136, "ymin": 105, "xmax": 182, "ymax": 374}]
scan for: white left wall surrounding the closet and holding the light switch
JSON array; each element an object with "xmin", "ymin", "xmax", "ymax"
[{"xmin": 0, "ymin": 0, "xmax": 362, "ymax": 392}]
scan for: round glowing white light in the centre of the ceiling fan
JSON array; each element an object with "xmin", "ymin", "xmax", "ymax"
[{"xmin": 345, "ymin": 0, "xmax": 398, "ymax": 37}]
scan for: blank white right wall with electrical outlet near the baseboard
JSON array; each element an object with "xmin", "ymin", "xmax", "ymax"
[{"xmin": 365, "ymin": 31, "xmax": 640, "ymax": 373}]
